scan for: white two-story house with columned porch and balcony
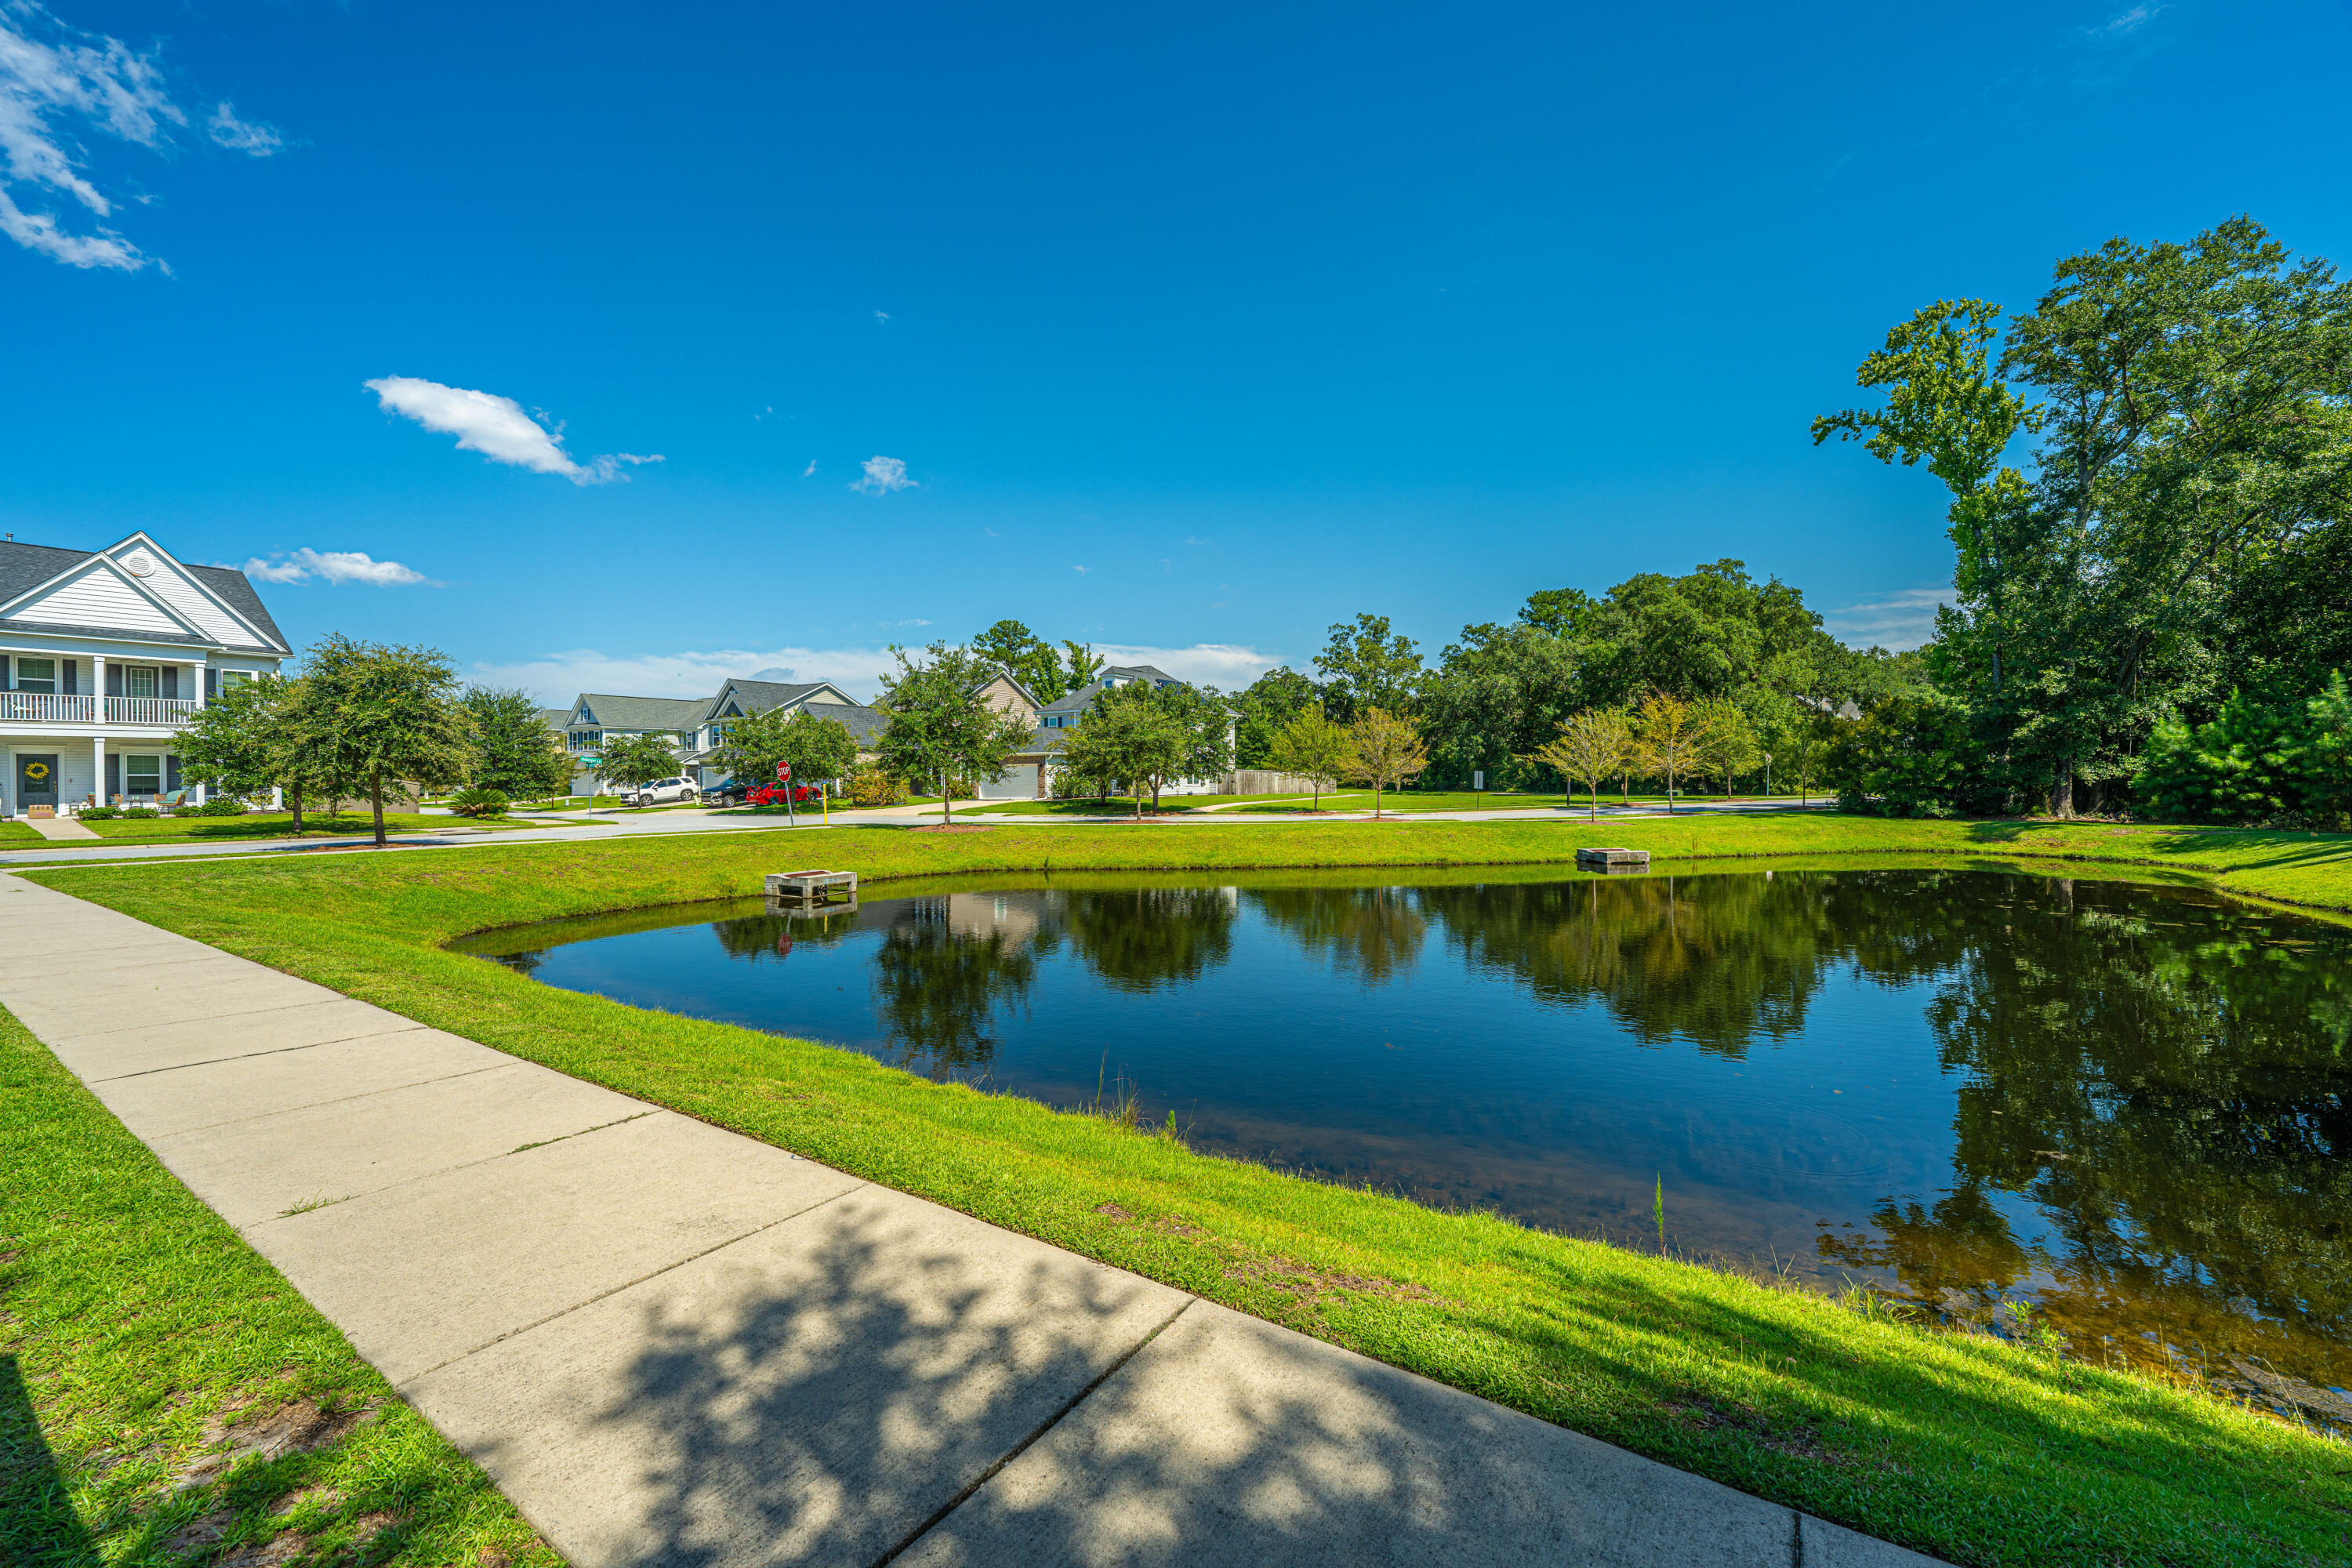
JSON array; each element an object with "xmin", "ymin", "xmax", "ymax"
[{"xmin": 0, "ymin": 534, "xmax": 292, "ymax": 815}]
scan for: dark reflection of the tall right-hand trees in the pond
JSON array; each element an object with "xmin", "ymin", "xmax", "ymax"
[{"xmin": 1823, "ymin": 881, "xmax": 2352, "ymax": 1382}]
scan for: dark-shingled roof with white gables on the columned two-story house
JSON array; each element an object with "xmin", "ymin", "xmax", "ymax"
[{"xmin": 0, "ymin": 532, "xmax": 292, "ymax": 654}]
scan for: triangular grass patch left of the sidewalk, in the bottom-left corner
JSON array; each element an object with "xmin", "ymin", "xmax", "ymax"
[{"xmin": 0, "ymin": 1013, "xmax": 562, "ymax": 1568}]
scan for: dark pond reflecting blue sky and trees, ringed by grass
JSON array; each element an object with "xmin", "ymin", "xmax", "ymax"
[{"xmin": 461, "ymin": 869, "xmax": 2352, "ymax": 1389}]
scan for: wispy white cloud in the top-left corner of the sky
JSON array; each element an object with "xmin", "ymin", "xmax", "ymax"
[{"xmin": 0, "ymin": 0, "xmax": 188, "ymax": 273}]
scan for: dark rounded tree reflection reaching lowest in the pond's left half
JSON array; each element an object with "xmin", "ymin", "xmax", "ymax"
[{"xmin": 873, "ymin": 898, "xmax": 1037, "ymax": 1076}]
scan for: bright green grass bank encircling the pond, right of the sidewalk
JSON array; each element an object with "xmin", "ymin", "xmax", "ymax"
[{"xmin": 28, "ymin": 815, "xmax": 2352, "ymax": 1568}]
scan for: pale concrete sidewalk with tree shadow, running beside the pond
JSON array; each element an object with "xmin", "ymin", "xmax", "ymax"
[{"xmin": 0, "ymin": 877, "xmax": 1929, "ymax": 1568}]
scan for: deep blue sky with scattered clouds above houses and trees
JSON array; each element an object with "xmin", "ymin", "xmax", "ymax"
[{"xmin": 0, "ymin": 0, "xmax": 2352, "ymax": 701}]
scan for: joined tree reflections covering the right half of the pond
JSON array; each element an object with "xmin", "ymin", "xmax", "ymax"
[{"xmin": 1418, "ymin": 872, "xmax": 2352, "ymax": 1385}]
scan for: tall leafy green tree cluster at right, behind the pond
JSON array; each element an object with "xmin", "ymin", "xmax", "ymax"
[{"xmin": 1813, "ymin": 216, "xmax": 2352, "ymax": 825}]
